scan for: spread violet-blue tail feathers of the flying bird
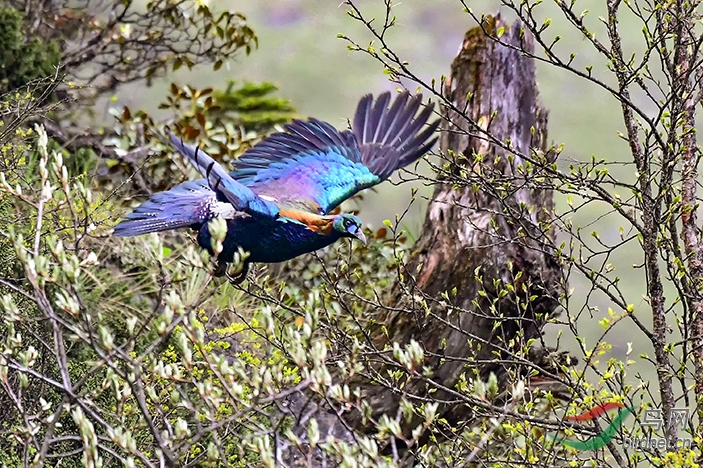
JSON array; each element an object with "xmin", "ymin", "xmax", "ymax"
[{"xmin": 114, "ymin": 179, "xmax": 212, "ymax": 237}]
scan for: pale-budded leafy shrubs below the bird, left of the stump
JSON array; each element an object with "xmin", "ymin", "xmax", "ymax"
[{"xmin": 0, "ymin": 114, "xmax": 418, "ymax": 466}]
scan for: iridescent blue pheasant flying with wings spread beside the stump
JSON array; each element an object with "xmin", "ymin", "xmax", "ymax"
[{"xmin": 114, "ymin": 92, "xmax": 439, "ymax": 280}]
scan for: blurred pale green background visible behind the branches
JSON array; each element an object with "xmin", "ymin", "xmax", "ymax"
[{"xmin": 113, "ymin": 0, "xmax": 664, "ymax": 390}]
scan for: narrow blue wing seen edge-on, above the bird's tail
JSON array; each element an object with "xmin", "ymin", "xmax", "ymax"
[{"xmin": 166, "ymin": 130, "xmax": 279, "ymax": 217}]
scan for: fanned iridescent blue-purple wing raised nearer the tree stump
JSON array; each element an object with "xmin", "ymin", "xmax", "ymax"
[{"xmin": 230, "ymin": 92, "xmax": 439, "ymax": 214}]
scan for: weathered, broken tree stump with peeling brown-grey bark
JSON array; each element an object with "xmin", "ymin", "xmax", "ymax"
[{"xmin": 349, "ymin": 14, "xmax": 563, "ymax": 438}]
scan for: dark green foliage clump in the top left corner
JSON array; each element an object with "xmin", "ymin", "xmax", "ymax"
[{"xmin": 0, "ymin": 6, "xmax": 61, "ymax": 93}]
